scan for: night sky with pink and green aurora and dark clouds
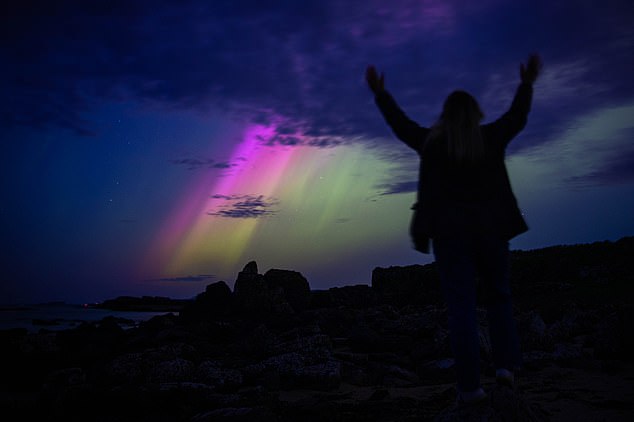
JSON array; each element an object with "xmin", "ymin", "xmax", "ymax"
[{"xmin": 0, "ymin": 0, "xmax": 634, "ymax": 303}]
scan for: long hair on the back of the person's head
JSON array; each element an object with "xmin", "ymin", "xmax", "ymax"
[{"xmin": 428, "ymin": 90, "xmax": 485, "ymax": 165}]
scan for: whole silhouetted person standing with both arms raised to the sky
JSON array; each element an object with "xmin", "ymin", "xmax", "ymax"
[{"xmin": 365, "ymin": 54, "xmax": 542, "ymax": 403}]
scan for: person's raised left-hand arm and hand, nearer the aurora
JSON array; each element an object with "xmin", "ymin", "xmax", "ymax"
[{"xmin": 365, "ymin": 65, "xmax": 429, "ymax": 152}]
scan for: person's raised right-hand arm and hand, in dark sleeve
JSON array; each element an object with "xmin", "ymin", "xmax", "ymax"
[{"xmin": 488, "ymin": 54, "xmax": 542, "ymax": 147}]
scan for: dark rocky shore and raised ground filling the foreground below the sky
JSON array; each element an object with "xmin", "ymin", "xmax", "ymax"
[{"xmin": 0, "ymin": 238, "xmax": 634, "ymax": 422}]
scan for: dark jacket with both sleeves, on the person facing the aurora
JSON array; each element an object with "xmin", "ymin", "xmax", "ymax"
[{"xmin": 375, "ymin": 83, "xmax": 533, "ymax": 253}]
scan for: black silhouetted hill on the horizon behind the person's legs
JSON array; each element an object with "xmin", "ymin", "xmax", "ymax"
[{"xmin": 372, "ymin": 236, "xmax": 634, "ymax": 317}]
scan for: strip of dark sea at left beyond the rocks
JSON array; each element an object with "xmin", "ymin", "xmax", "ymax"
[{"xmin": 0, "ymin": 303, "xmax": 173, "ymax": 332}]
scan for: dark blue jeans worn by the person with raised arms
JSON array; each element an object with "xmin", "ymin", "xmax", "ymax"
[{"xmin": 432, "ymin": 235, "xmax": 521, "ymax": 392}]
